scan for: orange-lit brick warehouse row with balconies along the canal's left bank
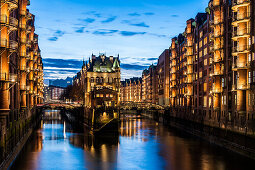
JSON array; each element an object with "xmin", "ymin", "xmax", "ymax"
[{"xmin": 0, "ymin": 0, "xmax": 43, "ymax": 161}]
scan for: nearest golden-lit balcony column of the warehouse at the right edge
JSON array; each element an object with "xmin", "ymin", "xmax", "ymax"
[{"xmin": 232, "ymin": 0, "xmax": 255, "ymax": 125}]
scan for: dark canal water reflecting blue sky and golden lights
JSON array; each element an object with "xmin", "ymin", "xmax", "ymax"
[{"xmin": 10, "ymin": 110, "xmax": 255, "ymax": 170}]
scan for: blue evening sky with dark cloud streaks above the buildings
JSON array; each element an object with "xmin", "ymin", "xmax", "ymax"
[{"xmin": 29, "ymin": 0, "xmax": 209, "ymax": 79}]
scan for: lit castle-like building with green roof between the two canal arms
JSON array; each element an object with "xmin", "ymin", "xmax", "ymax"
[{"xmin": 73, "ymin": 54, "xmax": 120, "ymax": 108}]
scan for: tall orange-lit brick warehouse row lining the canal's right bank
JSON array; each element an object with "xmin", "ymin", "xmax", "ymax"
[{"xmin": 169, "ymin": 0, "xmax": 255, "ymax": 130}]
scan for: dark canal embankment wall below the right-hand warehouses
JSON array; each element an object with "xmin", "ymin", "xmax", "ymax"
[{"xmin": 142, "ymin": 111, "xmax": 255, "ymax": 159}]
